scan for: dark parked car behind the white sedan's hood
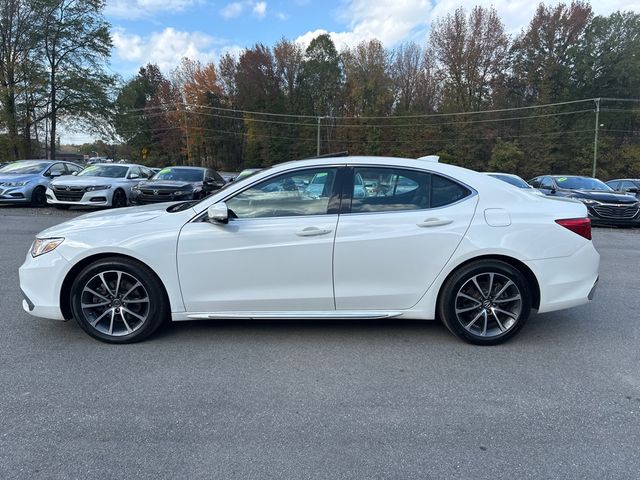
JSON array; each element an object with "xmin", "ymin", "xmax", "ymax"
[{"xmin": 131, "ymin": 167, "xmax": 225, "ymax": 205}]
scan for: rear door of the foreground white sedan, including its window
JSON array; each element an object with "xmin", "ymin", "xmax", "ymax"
[{"xmin": 334, "ymin": 167, "xmax": 478, "ymax": 310}]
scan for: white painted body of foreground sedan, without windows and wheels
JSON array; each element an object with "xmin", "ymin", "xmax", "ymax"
[{"xmin": 20, "ymin": 157, "xmax": 599, "ymax": 338}]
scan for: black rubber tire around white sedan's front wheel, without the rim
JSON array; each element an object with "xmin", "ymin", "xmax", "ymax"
[{"xmin": 70, "ymin": 258, "xmax": 169, "ymax": 343}]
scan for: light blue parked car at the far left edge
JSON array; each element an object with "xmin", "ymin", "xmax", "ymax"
[{"xmin": 0, "ymin": 160, "xmax": 82, "ymax": 207}]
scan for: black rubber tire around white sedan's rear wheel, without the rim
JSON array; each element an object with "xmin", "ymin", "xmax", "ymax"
[{"xmin": 438, "ymin": 260, "xmax": 532, "ymax": 345}]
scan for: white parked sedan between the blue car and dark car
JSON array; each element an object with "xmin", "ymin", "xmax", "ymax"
[{"xmin": 46, "ymin": 163, "xmax": 153, "ymax": 209}]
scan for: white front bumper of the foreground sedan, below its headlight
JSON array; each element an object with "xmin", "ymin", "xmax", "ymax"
[{"xmin": 18, "ymin": 250, "xmax": 69, "ymax": 320}]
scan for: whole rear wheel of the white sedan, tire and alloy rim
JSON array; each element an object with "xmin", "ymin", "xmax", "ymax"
[{"xmin": 438, "ymin": 260, "xmax": 532, "ymax": 345}]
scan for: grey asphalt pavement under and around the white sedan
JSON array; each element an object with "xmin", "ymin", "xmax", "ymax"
[{"xmin": 0, "ymin": 209, "xmax": 640, "ymax": 480}]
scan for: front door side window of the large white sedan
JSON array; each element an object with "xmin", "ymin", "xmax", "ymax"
[{"xmin": 227, "ymin": 168, "xmax": 337, "ymax": 218}]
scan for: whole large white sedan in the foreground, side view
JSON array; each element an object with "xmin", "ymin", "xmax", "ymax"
[{"xmin": 20, "ymin": 157, "xmax": 599, "ymax": 345}]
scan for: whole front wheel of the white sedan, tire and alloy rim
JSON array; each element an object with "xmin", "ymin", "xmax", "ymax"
[{"xmin": 70, "ymin": 257, "xmax": 169, "ymax": 343}]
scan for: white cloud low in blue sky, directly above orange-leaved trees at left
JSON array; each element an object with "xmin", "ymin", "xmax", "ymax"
[{"xmin": 112, "ymin": 27, "xmax": 241, "ymax": 72}]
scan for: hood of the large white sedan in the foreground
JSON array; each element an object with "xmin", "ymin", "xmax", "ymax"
[{"xmin": 37, "ymin": 203, "xmax": 168, "ymax": 238}]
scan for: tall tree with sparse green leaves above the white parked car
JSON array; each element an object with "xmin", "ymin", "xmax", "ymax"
[{"xmin": 33, "ymin": 0, "xmax": 113, "ymax": 158}]
